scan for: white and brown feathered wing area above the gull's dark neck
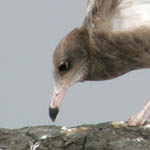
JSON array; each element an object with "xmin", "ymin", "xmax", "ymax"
[{"xmin": 84, "ymin": 0, "xmax": 150, "ymax": 31}]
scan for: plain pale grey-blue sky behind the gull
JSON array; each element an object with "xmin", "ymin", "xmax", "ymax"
[{"xmin": 0, "ymin": 0, "xmax": 150, "ymax": 128}]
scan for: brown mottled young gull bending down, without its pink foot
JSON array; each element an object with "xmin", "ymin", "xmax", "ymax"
[{"xmin": 50, "ymin": 0, "xmax": 150, "ymax": 123}]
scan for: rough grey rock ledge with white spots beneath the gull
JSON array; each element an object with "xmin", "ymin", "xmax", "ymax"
[{"xmin": 0, "ymin": 122, "xmax": 150, "ymax": 150}]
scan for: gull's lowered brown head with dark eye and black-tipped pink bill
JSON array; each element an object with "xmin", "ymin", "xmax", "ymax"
[{"xmin": 49, "ymin": 29, "xmax": 89, "ymax": 121}]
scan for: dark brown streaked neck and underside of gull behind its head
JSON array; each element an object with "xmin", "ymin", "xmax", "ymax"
[{"xmin": 87, "ymin": 29, "xmax": 150, "ymax": 80}]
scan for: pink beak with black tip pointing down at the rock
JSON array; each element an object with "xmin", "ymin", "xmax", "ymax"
[{"xmin": 49, "ymin": 86, "xmax": 67, "ymax": 121}]
